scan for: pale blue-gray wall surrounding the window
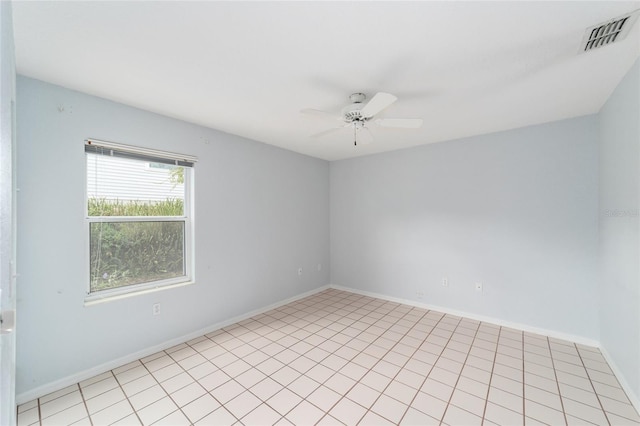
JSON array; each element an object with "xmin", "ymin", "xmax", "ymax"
[{"xmin": 17, "ymin": 77, "xmax": 330, "ymax": 394}]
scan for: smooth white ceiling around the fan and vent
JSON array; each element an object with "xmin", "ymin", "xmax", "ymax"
[{"xmin": 13, "ymin": 1, "xmax": 640, "ymax": 160}]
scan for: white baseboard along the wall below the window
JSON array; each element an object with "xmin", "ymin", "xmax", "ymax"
[{"xmin": 16, "ymin": 285, "xmax": 329, "ymax": 405}]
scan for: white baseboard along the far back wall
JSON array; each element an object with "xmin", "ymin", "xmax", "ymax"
[{"xmin": 329, "ymin": 284, "xmax": 600, "ymax": 348}]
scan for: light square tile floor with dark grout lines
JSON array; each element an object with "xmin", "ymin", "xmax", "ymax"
[{"xmin": 18, "ymin": 290, "xmax": 640, "ymax": 426}]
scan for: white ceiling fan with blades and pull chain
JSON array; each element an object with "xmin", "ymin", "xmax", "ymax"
[{"xmin": 300, "ymin": 92, "xmax": 422, "ymax": 145}]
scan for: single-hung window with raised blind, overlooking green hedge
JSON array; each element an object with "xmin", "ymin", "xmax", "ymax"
[{"xmin": 85, "ymin": 140, "xmax": 195, "ymax": 301}]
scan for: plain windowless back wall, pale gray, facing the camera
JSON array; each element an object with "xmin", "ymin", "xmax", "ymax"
[{"xmin": 331, "ymin": 116, "xmax": 598, "ymax": 340}]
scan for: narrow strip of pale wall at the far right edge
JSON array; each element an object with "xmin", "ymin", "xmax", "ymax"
[{"xmin": 599, "ymin": 61, "xmax": 640, "ymax": 402}]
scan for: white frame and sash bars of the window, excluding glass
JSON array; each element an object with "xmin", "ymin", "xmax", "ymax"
[{"xmin": 84, "ymin": 139, "xmax": 197, "ymax": 305}]
